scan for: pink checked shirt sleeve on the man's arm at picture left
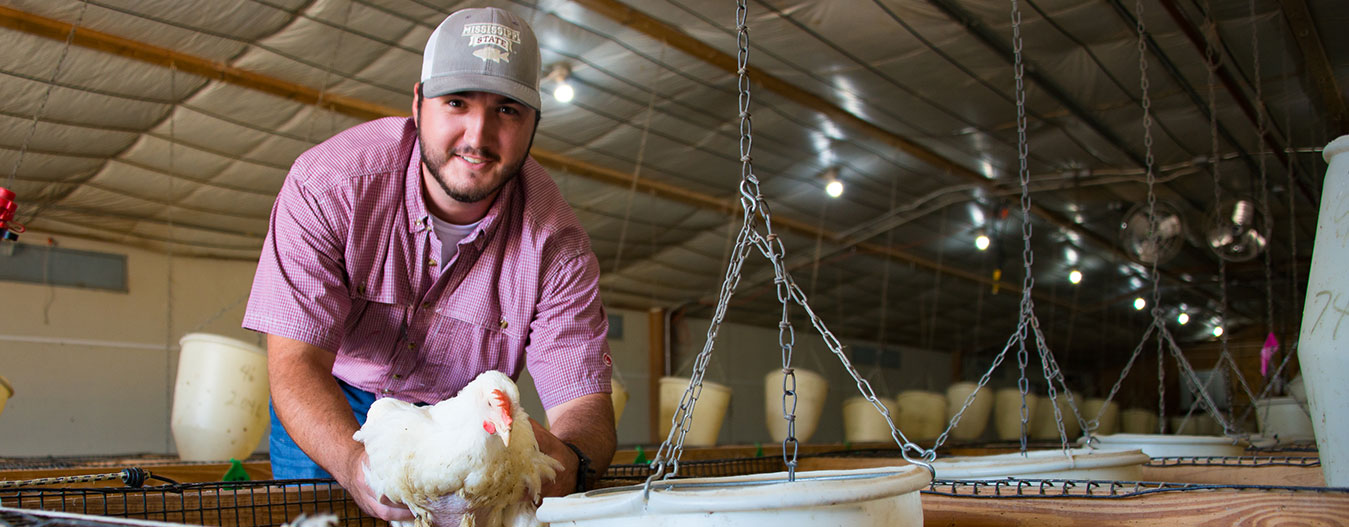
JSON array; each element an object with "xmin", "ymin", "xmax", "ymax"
[{"xmin": 243, "ymin": 171, "xmax": 351, "ymax": 352}]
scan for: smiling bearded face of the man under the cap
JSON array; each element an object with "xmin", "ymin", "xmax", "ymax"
[{"xmin": 413, "ymin": 86, "xmax": 536, "ymax": 204}]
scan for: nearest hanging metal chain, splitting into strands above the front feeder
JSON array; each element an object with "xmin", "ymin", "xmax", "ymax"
[{"xmin": 643, "ymin": 0, "xmax": 936, "ymax": 497}]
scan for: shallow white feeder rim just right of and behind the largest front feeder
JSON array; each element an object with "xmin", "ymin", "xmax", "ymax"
[{"xmin": 932, "ymin": 449, "xmax": 1151, "ymax": 481}]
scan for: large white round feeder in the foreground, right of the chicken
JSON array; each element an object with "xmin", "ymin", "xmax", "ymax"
[{"xmin": 538, "ymin": 465, "xmax": 931, "ymax": 527}]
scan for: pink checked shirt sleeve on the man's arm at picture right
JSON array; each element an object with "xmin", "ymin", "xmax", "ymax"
[{"xmin": 525, "ymin": 251, "xmax": 612, "ymax": 410}]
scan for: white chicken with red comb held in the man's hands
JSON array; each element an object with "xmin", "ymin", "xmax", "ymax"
[{"xmin": 352, "ymin": 371, "xmax": 563, "ymax": 527}]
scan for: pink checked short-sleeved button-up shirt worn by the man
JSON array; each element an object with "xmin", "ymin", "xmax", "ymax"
[{"xmin": 243, "ymin": 117, "xmax": 611, "ymax": 408}]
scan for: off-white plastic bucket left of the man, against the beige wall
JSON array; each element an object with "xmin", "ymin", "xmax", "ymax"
[{"xmin": 171, "ymin": 333, "xmax": 268, "ymax": 461}]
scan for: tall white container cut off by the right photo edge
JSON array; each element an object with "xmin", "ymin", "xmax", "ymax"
[{"xmin": 1298, "ymin": 136, "xmax": 1349, "ymax": 487}]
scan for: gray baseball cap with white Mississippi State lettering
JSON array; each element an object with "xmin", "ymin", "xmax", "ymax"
[{"xmin": 421, "ymin": 7, "xmax": 541, "ymax": 111}]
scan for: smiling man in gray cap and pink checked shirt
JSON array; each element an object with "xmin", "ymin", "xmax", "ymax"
[{"xmin": 244, "ymin": 8, "xmax": 615, "ymax": 520}]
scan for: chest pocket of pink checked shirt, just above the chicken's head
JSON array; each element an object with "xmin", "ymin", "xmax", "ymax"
[{"xmin": 426, "ymin": 313, "xmax": 525, "ymax": 385}]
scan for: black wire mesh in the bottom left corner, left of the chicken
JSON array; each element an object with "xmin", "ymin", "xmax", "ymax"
[{"xmin": 0, "ymin": 480, "xmax": 386, "ymax": 527}]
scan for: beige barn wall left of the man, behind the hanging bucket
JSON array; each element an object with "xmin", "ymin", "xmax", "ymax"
[{"xmin": 0, "ymin": 232, "xmax": 258, "ymax": 456}]
